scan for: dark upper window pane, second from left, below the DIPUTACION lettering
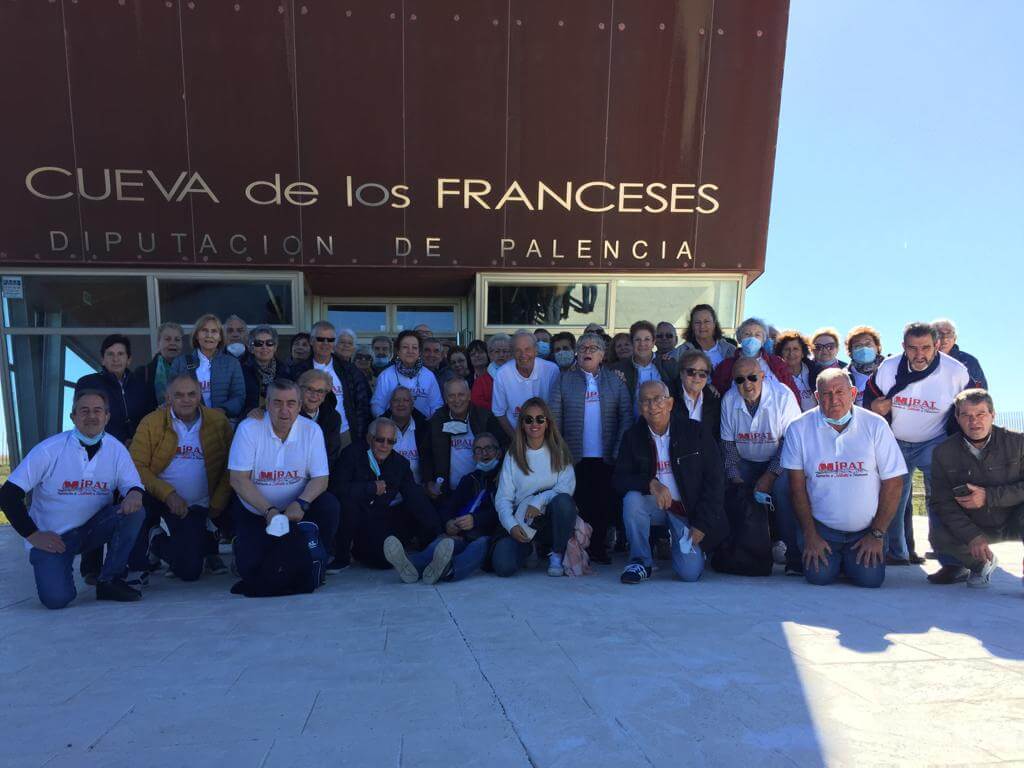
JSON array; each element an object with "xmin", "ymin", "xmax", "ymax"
[{"xmin": 159, "ymin": 278, "xmax": 294, "ymax": 327}]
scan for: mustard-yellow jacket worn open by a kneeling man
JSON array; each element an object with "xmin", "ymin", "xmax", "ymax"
[{"xmin": 129, "ymin": 403, "xmax": 232, "ymax": 517}]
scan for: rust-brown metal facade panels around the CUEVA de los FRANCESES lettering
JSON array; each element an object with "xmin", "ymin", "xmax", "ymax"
[{"xmin": 0, "ymin": 0, "xmax": 788, "ymax": 295}]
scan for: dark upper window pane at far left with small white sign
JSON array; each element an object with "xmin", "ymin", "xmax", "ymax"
[{"xmin": 3, "ymin": 274, "xmax": 150, "ymax": 328}]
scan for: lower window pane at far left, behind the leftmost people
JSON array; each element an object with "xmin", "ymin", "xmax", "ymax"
[{"xmin": 6, "ymin": 334, "xmax": 153, "ymax": 457}]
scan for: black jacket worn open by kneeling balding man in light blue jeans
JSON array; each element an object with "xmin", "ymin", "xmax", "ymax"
[{"xmin": 612, "ymin": 415, "xmax": 728, "ymax": 552}]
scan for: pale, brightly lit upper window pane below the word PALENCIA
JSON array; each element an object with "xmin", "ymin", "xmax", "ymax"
[{"xmin": 615, "ymin": 280, "xmax": 739, "ymax": 330}]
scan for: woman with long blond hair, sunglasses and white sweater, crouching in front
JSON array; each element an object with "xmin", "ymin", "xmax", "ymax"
[{"xmin": 490, "ymin": 397, "xmax": 577, "ymax": 577}]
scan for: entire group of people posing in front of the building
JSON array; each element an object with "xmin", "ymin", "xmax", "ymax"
[{"xmin": 6, "ymin": 304, "xmax": 1024, "ymax": 608}]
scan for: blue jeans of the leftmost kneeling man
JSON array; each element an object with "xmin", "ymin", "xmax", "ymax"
[{"xmin": 29, "ymin": 506, "xmax": 145, "ymax": 609}]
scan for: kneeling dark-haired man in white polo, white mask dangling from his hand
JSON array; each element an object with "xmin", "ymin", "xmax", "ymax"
[{"xmin": 227, "ymin": 379, "xmax": 340, "ymax": 597}]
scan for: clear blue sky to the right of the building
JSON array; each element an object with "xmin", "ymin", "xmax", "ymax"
[{"xmin": 745, "ymin": 0, "xmax": 1024, "ymax": 411}]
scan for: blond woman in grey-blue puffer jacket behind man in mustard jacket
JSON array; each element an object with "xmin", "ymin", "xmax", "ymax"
[{"xmin": 171, "ymin": 313, "xmax": 246, "ymax": 421}]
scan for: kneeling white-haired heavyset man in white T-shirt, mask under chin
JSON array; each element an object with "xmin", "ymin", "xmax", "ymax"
[{"xmin": 782, "ymin": 368, "xmax": 906, "ymax": 587}]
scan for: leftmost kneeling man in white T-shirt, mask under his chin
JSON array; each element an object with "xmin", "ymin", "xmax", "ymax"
[{"xmin": 0, "ymin": 389, "xmax": 145, "ymax": 608}]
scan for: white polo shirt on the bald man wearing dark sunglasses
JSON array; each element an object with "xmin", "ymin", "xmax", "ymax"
[{"xmin": 722, "ymin": 379, "xmax": 800, "ymax": 462}]
